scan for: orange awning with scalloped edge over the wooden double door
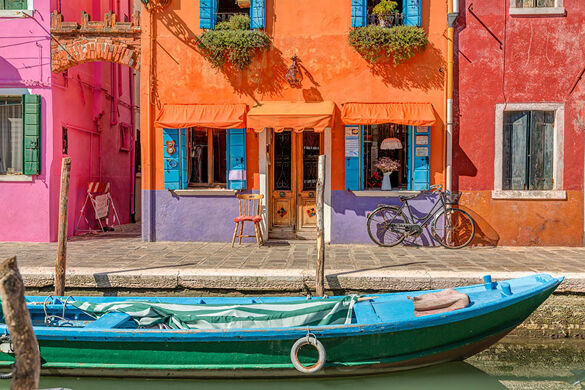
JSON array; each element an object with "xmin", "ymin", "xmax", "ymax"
[{"xmin": 248, "ymin": 102, "xmax": 335, "ymax": 133}]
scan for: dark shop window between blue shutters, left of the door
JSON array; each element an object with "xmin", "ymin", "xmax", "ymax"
[{"xmin": 188, "ymin": 127, "xmax": 227, "ymax": 188}]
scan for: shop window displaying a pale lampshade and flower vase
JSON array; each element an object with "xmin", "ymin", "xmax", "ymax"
[{"xmin": 363, "ymin": 123, "xmax": 408, "ymax": 190}]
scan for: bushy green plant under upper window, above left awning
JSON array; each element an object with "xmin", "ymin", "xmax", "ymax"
[{"xmin": 197, "ymin": 15, "xmax": 270, "ymax": 70}]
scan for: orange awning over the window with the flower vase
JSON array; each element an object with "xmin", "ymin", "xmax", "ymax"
[{"xmin": 341, "ymin": 103, "xmax": 436, "ymax": 126}]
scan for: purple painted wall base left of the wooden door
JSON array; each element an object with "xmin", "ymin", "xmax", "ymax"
[{"xmin": 147, "ymin": 190, "xmax": 256, "ymax": 242}]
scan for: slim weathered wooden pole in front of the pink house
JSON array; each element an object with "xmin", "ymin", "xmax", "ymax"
[{"xmin": 55, "ymin": 157, "xmax": 71, "ymax": 296}]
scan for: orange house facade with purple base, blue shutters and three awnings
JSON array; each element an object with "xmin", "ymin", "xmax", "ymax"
[{"xmin": 141, "ymin": 0, "xmax": 448, "ymax": 244}]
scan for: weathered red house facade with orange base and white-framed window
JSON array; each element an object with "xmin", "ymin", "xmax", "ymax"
[{"xmin": 453, "ymin": 0, "xmax": 585, "ymax": 246}]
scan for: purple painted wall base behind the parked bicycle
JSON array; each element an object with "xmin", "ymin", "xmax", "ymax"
[{"xmin": 331, "ymin": 191, "xmax": 439, "ymax": 246}]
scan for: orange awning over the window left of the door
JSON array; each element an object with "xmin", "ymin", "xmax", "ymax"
[{"xmin": 154, "ymin": 104, "xmax": 248, "ymax": 129}]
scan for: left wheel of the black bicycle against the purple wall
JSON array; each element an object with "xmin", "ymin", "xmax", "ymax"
[{"xmin": 368, "ymin": 206, "xmax": 408, "ymax": 246}]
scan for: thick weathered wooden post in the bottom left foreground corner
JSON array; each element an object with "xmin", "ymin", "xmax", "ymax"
[{"xmin": 0, "ymin": 257, "xmax": 41, "ymax": 390}]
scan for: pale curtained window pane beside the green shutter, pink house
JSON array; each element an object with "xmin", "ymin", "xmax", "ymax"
[{"xmin": 0, "ymin": 101, "xmax": 23, "ymax": 174}]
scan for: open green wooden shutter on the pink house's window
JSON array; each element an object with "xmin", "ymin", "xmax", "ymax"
[{"xmin": 22, "ymin": 95, "xmax": 41, "ymax": 175}]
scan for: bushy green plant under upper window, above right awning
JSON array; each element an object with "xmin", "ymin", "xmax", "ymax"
[{"xmin": 349, "ymin": 26, "xmax": 428, "ymax": 66}]
